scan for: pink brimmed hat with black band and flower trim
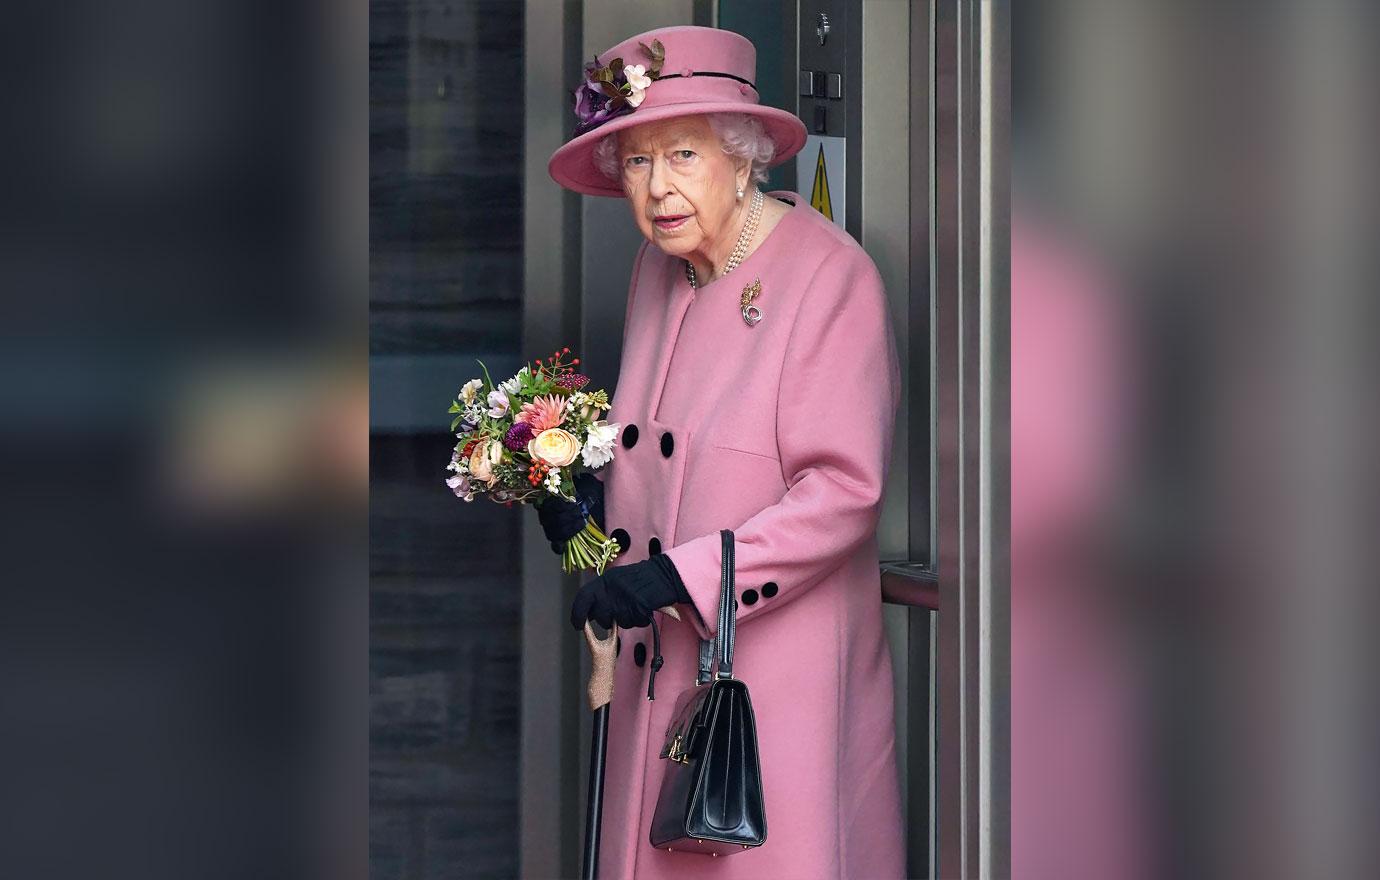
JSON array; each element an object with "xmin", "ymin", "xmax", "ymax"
[{"xmin": 548, "ymin": 26, "xmax": 805, "ymax": 196}]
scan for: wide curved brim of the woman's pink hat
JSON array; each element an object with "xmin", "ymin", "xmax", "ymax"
[{"xmin": 546, "ymin": 101, "xmax": 806, "ymax": 197}]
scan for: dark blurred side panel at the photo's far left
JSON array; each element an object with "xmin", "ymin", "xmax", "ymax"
[{"xmin": 0, "ymin": 0, "xmax": 367, "ymax": 879}]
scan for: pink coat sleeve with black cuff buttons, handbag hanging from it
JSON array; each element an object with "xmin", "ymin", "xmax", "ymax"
[{"xmin": 667, "ymin": 248, "xmax": 901, "ymax": 639}]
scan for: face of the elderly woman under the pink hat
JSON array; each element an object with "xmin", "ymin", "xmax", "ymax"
[{"xmin": 618, "ymin": 116, "xmax": 751, "ymax": 259}]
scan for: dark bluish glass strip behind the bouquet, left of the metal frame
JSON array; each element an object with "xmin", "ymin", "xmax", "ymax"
[{"xmin": 370, "ymin": 0, "xmax": 523, "ymax": 880}]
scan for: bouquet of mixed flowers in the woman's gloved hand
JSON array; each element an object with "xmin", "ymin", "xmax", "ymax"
[{"xmin": 446, "ymin": 348, "xmax": 621, "ymax": 574}]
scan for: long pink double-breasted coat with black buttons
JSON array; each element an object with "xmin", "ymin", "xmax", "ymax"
[{"xmin": 599, "ymin": 193, "xmax": 905, "ymax": 880}]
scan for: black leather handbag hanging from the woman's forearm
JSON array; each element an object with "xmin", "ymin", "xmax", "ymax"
[{"xmin": 650, "ymin": 528, "xmax": 767, "ymax": 855}]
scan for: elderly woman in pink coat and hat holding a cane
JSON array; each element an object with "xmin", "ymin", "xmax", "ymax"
[{"xmin": 541, "ymin": 28, "xmax": 905, "ymax": 880}]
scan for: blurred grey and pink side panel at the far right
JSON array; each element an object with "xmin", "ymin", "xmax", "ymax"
[{"xmin": 1012, "ymin": 0, "xmax": 1380, "ymax": 880}]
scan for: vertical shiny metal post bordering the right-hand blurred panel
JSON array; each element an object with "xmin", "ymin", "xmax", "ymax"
[{"xmin": 934, "ymin": 0, "xmax": 1010, "ymax": 879}]
